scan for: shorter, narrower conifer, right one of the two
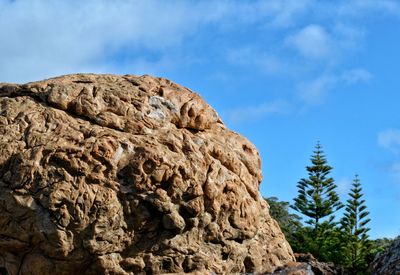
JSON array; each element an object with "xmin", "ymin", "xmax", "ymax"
[{"xmin": 341, "ymin": 175, "xmax": 371, "ymax": 274}]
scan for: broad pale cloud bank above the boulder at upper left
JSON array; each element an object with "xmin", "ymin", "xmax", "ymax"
[{"xmin": 0, "ymin": 0, "xmax": 244, "ymax": 82}]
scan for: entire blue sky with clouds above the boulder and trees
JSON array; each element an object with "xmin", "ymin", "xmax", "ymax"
[{"xmin": 0, "ymin": 0, "xmax": 400, "ymax": 238}]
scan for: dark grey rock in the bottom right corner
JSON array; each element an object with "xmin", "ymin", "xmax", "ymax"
[{"xmin": 370, "ymin": 239, "xmax": 400, "ymax": 275}]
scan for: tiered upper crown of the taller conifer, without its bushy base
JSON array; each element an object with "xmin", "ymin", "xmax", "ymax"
[{"xmin": 291, "ymin": 142, "xmax": 343, "ymax": 234}]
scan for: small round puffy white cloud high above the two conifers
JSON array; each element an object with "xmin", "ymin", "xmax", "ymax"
[{"xmin": 286, "ymin": 25, "xmax": 333, "ymax": 59}]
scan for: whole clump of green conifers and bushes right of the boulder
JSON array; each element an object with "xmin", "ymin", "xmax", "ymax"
[{"xmin": 266, "ymin": 143, "xmax": 400, "ymax": 275}]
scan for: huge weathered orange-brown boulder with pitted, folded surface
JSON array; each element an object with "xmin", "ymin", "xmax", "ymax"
[{"xmin": 0, "ymin": 74, "xmax": 294, "ymax": 275}]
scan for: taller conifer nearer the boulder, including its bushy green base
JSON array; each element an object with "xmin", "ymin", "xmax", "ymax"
[{"xmin": 291, "ymin": 143, "xmax": 343, "ymax": 261}]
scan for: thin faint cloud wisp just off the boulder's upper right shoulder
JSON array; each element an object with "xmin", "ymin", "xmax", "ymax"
[{"xmin": 222, "ymin": 100, "xmax": 291, "ymax": 123}]
